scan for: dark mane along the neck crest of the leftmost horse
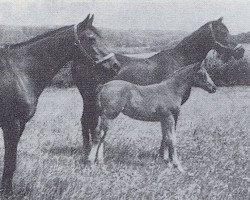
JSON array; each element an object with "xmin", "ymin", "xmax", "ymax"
[{"xmin": 8, "ymin": 25, "xmax": 72, "ymax": 49}]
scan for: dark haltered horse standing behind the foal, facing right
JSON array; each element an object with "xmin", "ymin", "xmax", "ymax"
[{"xmin": 72, "ymin": 18, "xmax": 244, "ymax": 163}]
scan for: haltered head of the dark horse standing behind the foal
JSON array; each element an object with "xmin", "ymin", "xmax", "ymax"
[{"xmin": 206, "ymin": 17, "xmax": 245, "ymax": 62}]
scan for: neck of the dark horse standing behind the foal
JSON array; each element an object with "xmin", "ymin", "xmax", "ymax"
[{"xmin": 172, "ymin": 31, "xmax": 212, "ymax": 66}]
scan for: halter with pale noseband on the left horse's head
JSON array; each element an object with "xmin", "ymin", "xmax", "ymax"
[{"xmin": 74, "ymin": 24, "xmax": 115, "ymax": 65}]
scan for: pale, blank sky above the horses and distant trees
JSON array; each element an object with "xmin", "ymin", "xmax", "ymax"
[{"xmin": 0, "ymin": 0, "xmax": 250, "ymax": 34}]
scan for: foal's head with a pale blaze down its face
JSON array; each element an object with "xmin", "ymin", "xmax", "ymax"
[{"xmin": 193, "ymin": 63, "xmax": 216, "ymax": 93}]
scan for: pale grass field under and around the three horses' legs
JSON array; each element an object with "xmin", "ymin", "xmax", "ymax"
[{"xmin": 0, "ymin": 87, "xmax": 250, "ymax": 200}]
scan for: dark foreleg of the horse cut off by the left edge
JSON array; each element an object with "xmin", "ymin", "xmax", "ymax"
[{"xmin": 1, "ymin": 120, "xmax": 25, "ymax": 195}]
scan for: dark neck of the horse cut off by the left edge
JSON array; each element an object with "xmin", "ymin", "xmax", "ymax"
[{"xmin": 20, "ymin": 29, "xmax": 74, "ymax": 88}]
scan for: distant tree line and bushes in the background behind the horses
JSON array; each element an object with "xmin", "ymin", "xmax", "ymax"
[{"xmin": 0, "ymin": 26, "xmax": 250, "ymax": 87}]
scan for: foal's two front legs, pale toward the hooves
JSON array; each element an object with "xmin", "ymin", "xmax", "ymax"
[{"xmin": 159, "ymin": 115, "xmax": 184, "ymax": 172}]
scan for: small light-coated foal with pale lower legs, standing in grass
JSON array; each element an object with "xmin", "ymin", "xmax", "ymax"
[{"xmin": 93, "ymin": 63, "xmax": 216, "ymax": 172}]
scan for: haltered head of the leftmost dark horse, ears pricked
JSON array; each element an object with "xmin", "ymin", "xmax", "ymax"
[{"xmin": 74, "ymin": 15, "xmax": 120, "ymax": 75}]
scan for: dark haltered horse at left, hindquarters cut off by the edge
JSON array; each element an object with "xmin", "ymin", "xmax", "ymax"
[{"xmin": 0, "ymin": 16, "xmax": 117, "ymax": 194}]
